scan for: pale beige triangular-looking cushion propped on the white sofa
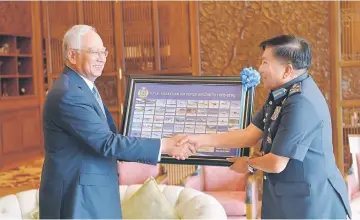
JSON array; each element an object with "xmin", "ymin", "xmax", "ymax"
[{"xmin": 121, "ymin": 177, "xmax": 180, "ymax": 219}]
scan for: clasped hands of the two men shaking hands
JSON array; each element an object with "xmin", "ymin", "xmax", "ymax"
[{"xmin": 161, "ymin": 134, "xmax": 200, "ymax": 160}]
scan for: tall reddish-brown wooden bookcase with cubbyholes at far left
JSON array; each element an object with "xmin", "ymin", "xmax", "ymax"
[{"xmin": 0, "ymin": 1, "xmax": 44, "ymax": 170}]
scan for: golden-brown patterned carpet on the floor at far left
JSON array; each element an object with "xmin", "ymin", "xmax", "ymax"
[{"xmin": 0, "ymin": 159, "xmax": 43, "ymax": 197}]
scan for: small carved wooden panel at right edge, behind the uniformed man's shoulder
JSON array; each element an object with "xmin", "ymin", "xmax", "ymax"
[{"xmin": 341, "ymin": 67, "xmax": 360, "ymax": 100}]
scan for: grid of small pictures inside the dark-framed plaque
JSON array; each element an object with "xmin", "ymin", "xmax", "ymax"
[{"xmin": 130, "ymin": 98, "xmax": 241, "ymax": 155}]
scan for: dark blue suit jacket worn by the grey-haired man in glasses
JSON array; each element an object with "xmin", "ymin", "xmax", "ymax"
[{"xmin": 39, "ymin": 67, "xmax": 160, "ymax": 219}]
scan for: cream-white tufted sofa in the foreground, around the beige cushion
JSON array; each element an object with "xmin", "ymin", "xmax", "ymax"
[{"xmin": 0, "ymin": 184, "xmax": 227, "ymax": 220}]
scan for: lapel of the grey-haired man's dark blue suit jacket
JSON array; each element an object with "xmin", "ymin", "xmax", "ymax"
[{"xmin": 64, "ymin": 66, "xmax": 107, "ymax": 120}]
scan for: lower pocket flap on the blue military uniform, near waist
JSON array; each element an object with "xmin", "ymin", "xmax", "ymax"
[{"xmin": 275, "ymin": 182, "xmax": 310, "ymax": 197}]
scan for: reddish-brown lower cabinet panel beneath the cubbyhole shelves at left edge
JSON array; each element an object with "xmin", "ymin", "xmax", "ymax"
[{"xmin": 0, "ymin": 111, "xmax": 21, "ymax": 156}]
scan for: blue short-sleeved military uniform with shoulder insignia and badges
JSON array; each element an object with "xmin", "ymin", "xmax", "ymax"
[{"xmin": 253, "ymin": 73, "xmax": 351, "ymax": 219}]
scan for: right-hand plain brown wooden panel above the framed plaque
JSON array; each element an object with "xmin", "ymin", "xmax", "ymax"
[{"xmin": 157, "ymin": 1, "xmax": 191, "ymax": 69}]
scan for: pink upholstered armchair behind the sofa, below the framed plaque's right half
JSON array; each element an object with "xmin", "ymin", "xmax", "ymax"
[{"xmin": 183, "ymin": 166, "xmax": 257, "ymax": 218}]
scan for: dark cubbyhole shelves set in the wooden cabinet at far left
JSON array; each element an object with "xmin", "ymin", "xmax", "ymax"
[{"xmin": 0, "ymin": 34, "xmax": 34, "ymax": 99}]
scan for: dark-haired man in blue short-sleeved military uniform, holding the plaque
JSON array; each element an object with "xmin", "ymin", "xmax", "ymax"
[{"xmin": 179, "ymin": 35, "xmax": 351, "ymax": 219}]
